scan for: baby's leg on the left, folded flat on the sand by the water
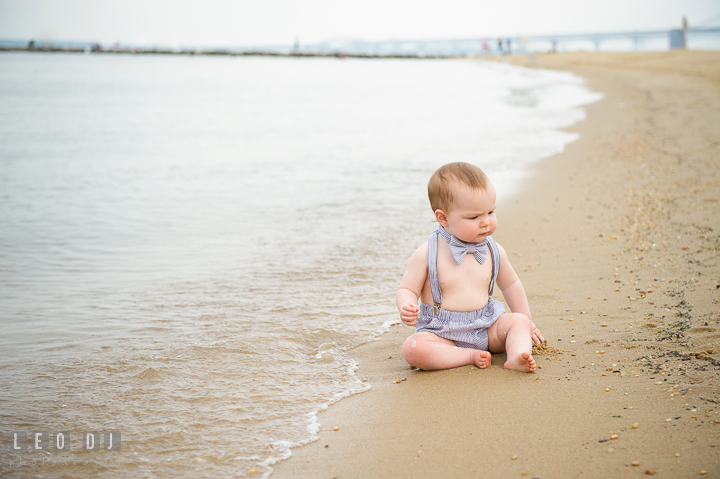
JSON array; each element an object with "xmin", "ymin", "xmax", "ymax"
[{"xmin": 403, "ymin": 331, "xmax": 491, "ymax": 371}]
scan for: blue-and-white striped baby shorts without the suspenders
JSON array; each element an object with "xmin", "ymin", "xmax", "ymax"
[{"xmin": 415, "ymin": 299, "xmax": 505, "ymax": 351}]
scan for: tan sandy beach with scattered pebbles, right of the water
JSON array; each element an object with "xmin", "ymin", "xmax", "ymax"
[{"xmin": 273, "ymin": 51, "xmax": 720, "ymax": 479}]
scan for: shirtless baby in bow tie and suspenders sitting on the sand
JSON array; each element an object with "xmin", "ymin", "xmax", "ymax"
[{"xmin": 397, "ymin": 163, "xmax": 545, "ymax": 372}]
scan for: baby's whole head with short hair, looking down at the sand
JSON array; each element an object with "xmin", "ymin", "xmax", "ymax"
[{"xmin": 428, "ymin": 162, "xmax": 497, "ymax": 242}]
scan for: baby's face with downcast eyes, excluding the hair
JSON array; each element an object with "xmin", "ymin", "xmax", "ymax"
[{"xmin": 441, "ymin": 182, "xmax": 497, "ymax": 243}]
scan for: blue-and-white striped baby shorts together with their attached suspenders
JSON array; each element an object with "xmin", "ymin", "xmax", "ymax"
[{"xmin": 415, "ymin": 227, "xmax": 505, "ymax": 351}]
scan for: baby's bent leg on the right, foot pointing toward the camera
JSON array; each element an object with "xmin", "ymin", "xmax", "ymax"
[{"xmin": 488, "ymin": 313, "xmax": 535, "ymax": 373}]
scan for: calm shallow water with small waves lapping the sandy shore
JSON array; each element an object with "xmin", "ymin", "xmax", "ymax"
[{"xmin": 0, "ymin": 54, "xmax": 597, "ymax": 478}]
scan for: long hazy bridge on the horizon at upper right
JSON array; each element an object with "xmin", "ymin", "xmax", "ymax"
[{"xmin": 308, "ymin": 27, "xmax": 720, "ymax": 55}]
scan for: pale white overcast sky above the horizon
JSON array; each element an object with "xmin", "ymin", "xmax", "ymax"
[{"xmin": 0, "ymin": 0, "xmax": 720, "ymax": 46}]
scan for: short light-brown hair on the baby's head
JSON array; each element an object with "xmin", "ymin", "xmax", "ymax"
[{"xmin": 428, "ymin": 161, "xmax": 488, "ymax": 213}]
